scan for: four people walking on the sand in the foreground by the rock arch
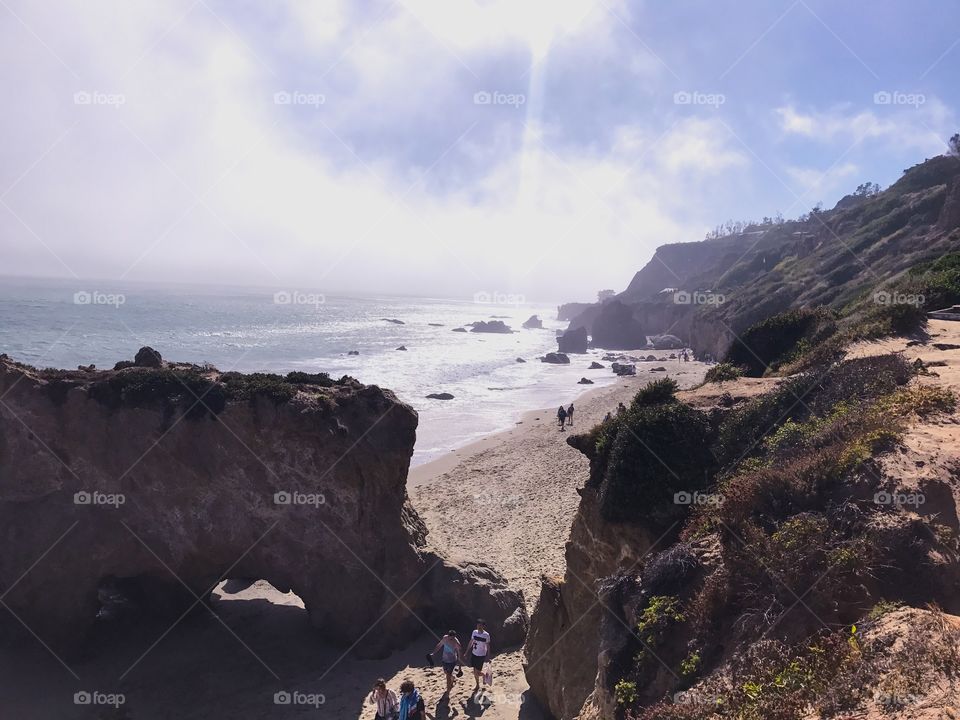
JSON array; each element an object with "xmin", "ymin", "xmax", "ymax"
[{"xmin": 367, "ymin": 620, "xmax": 493, "ymax": 720}]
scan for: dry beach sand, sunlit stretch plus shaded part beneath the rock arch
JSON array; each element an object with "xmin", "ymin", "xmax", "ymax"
[{"xmin": 0, "ymin": 360, "xmax": 705, "ymax": 720}]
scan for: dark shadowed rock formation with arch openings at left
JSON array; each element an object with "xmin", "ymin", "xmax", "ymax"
[{"xmin": 0, "ymin": 356, "xmax": 526, "ymax": 653}]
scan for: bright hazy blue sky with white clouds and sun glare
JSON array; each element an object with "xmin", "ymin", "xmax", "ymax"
[{"xmin": 0, "ymin": 0, "xmax": 960, "ymax": 301}]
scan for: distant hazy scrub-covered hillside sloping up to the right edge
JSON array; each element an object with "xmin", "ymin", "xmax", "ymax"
[{"xmin": 570, "ymin": 156, "xmax": 960, "ymax": 357}]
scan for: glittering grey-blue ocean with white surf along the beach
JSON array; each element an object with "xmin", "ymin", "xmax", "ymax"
[{"xmin": 0, "ymin": 278, "xmax": 632, "ymax": 465}]
